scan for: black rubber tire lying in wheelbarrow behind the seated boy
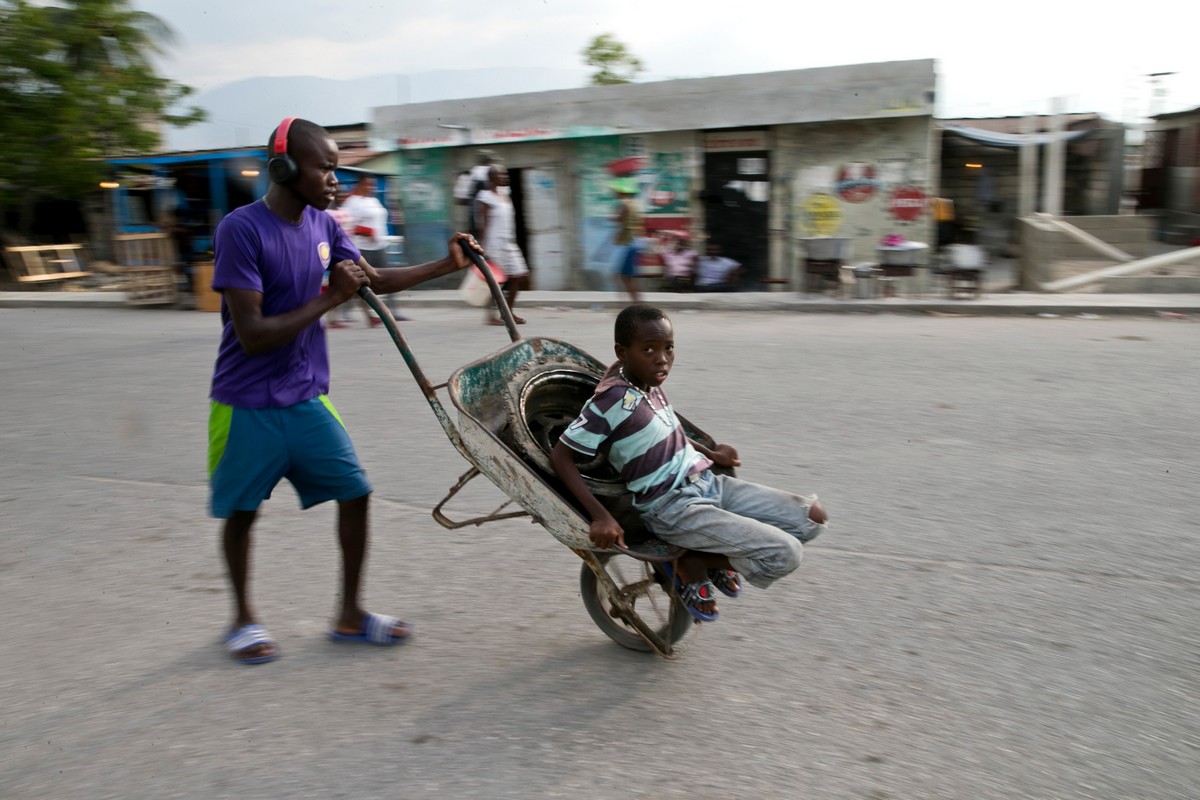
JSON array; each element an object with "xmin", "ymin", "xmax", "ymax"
[{"xmin": 502, "ymin": 357, "xmax": 626, "ymax": 497}]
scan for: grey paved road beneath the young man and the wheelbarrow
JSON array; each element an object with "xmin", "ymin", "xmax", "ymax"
[{"xmin": 0, "ymin": 308, "xmax": 1200, "ymax": 800}]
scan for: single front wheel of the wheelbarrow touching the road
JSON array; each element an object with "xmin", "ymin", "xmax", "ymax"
[{"xmin": 580, "ymin": 553, "xmax": 692, "ymax": 652}]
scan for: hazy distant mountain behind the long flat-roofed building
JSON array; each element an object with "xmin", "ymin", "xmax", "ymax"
[{"xmin": 164, "ymin": 67, "xmax": 588, "ymax": 150}]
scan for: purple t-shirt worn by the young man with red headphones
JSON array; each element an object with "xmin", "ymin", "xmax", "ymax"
[{"xmin": 211, "ymin": 200, "xmax": 359, "ymax": 408}]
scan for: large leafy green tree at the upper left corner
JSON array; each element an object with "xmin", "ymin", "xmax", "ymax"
[{"xmin": 0, "ymin": 0, "xmax": 204, "ymax": 231}]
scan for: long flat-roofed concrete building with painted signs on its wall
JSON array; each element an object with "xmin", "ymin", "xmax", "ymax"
[{"xmin": 371, "ymin": 60, "xmax": 938, "ymax": 290}]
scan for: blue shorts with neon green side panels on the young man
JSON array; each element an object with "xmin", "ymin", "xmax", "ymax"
[{"xmin": 209, "ymin": 395, "xmax": 371, "ymax": 519}]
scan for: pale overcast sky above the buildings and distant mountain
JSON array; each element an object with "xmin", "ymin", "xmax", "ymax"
[{"xmin": 132, "ymin": 0, "xmax": 1200, "ymax": 122}]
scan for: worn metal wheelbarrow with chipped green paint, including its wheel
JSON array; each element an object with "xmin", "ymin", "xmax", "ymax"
[{"xmin": 359, "ymin": 245, "xmax": 714, "ymax": 658}]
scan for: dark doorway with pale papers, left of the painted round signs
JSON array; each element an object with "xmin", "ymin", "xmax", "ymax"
[{"xmin": 702, "ymin": 150, "xmax": 770, "ymax": 289}]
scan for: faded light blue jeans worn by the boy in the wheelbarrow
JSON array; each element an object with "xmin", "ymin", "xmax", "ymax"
[{"xmin": 642, "ymin": 470, "xmax": 827, "ymax": 589}]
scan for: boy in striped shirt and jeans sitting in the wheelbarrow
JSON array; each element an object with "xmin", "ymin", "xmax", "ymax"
[{"xmin": 551, "ymin": 305, "xmax": 827, "ymax": 622}]
